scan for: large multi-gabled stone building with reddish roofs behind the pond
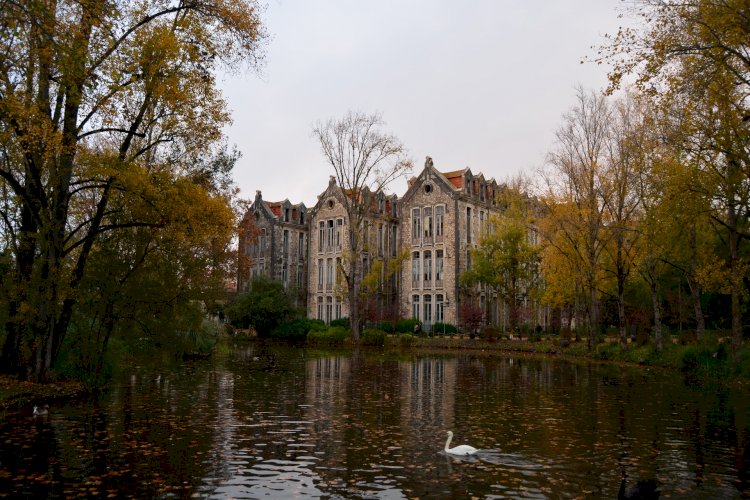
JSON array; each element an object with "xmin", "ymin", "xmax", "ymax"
[{"xmin": 237, "ymin": 157, "xmax": 524, "ymax": 328}]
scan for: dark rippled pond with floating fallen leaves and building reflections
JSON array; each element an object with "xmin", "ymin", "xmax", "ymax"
[{"xmin": 0, "ymin": 344, "xmax": 750, "ymax": 499}]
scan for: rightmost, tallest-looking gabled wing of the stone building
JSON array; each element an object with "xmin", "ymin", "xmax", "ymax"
[{"xmin": 400, "ymin": 157, "xmax": 500, "ymax": 328}]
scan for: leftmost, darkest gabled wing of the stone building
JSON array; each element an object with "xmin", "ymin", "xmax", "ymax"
[{"xmin": 237, "ymin": 191, "xmax": 310, "ymax": 307}]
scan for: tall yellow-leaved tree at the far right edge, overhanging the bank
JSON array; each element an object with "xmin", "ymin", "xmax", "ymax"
[{"xmin": 600, "ymin": 0, "xmax": 750, "ymax": 357}]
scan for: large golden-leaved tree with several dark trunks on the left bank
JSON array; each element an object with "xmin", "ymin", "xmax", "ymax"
[{"xmin": 0, "ymin": 0, "xmax": 264, "ymax": 380}]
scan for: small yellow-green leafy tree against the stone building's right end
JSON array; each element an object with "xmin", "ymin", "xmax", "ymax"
[{"xmin": 461, "ymin": 181, "xmax": 539, "ymax": 332}]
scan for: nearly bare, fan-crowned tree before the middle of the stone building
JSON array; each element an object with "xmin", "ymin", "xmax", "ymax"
[{"xmin": 313, "ymin": 111, "xmax": 411, "ymax": 342}]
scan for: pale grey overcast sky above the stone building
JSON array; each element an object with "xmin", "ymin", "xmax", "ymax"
[{"xmin": 220, "ymin": 0, "xmax": 636, "ymax": 207}]
